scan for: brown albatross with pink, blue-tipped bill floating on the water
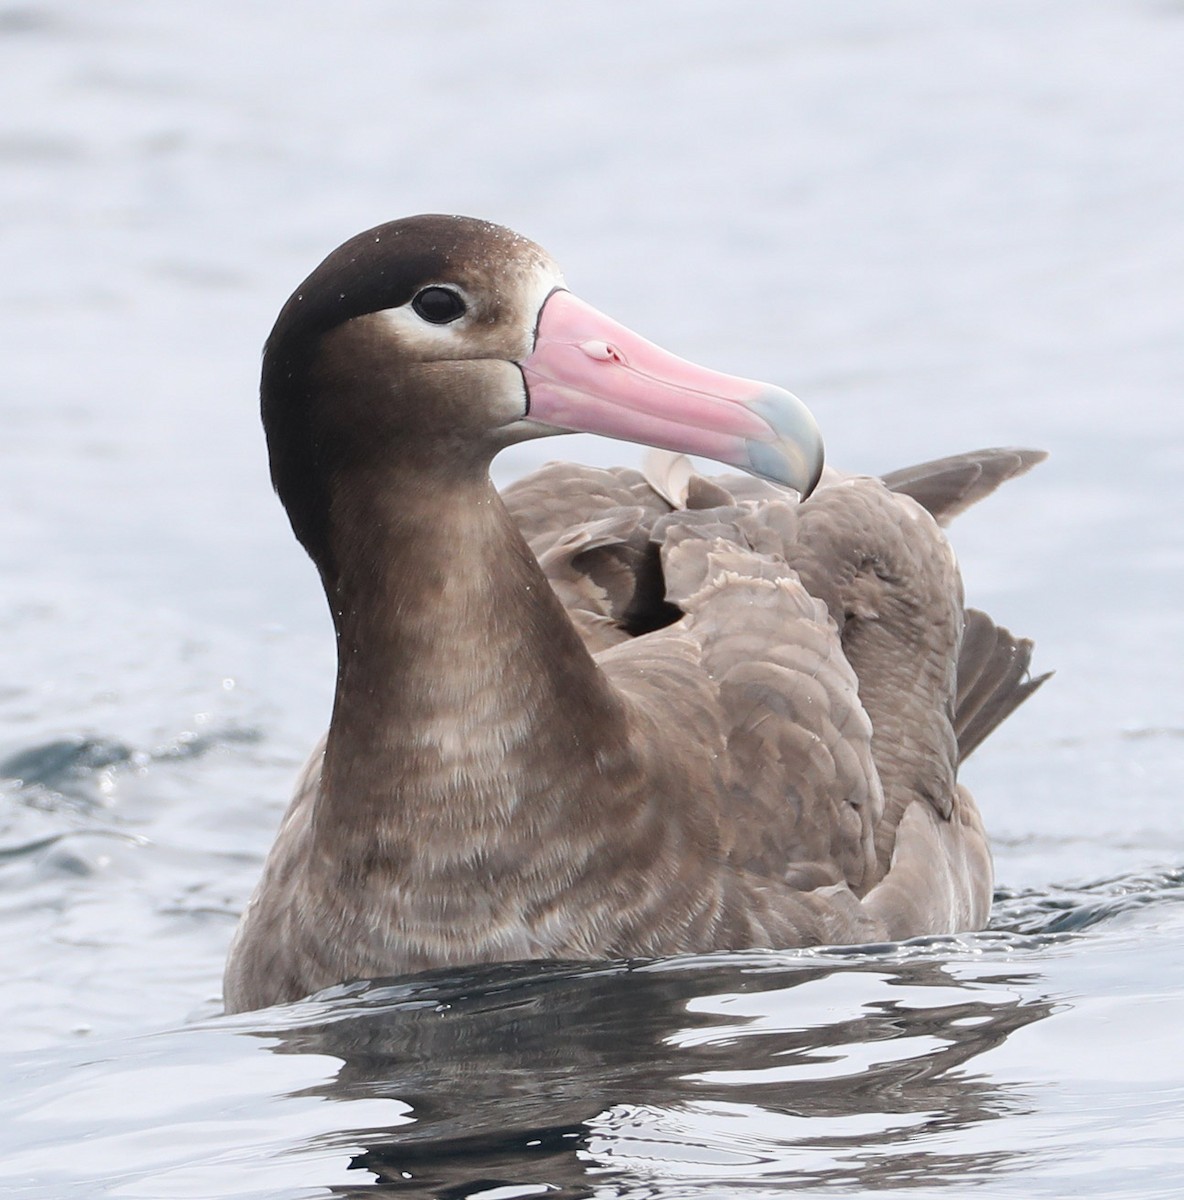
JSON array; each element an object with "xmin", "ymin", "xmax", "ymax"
[{"xmin": 224, "ymin": 216, "xmax": 1045, "ymax": 1012}]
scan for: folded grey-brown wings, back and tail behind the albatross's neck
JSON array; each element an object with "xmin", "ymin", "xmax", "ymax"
[{"xmin": 506, "ymin": 450, "xmax": 1047, "ymax": 941}]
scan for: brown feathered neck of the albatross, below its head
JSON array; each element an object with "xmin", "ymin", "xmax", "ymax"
[{"xmin": 314, "ymin": 472, "xmax": 629, "ymax": 869}]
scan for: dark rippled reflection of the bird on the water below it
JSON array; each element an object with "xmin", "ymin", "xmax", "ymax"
[{"xmin": 241, "ymin": 948, "xmax": 1053, "ymax": 1200}]
